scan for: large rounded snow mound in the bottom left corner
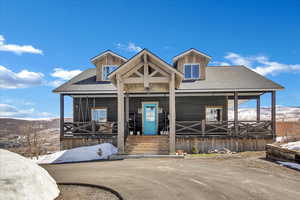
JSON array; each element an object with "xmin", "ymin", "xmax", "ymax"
[{"xmin": 0, "ymin": 149, "xmax": 59, "ymax": 200}]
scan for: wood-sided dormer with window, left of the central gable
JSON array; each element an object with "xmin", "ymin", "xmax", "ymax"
[{"xmin": 91, "ymin": 50, "xmax": 127, "ymax": 81}]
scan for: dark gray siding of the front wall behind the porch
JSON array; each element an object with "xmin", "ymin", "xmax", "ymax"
[{"xmin": 73, "ymin": 96, "xmax": 227, "ymax": 131}]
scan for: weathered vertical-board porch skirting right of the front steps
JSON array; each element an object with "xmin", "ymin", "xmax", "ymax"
[{"xmin": 176, "ymin": 136, "xmax": 273, "ymax": 153}]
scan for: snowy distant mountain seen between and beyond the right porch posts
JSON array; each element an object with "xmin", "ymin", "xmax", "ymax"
[{"xmin": 228, "ymin": 106, "xmax": 300, "ymax": 121}]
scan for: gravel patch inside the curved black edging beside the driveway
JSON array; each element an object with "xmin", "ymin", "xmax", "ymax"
[{"xmin": 56, "ymin": 185, "xmax": 119, "ymax": 200}]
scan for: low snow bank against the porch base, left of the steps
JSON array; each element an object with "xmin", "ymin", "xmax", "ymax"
[{"xmin": 33, "ymin": 143, "xmax": 118, "ymax": 164}]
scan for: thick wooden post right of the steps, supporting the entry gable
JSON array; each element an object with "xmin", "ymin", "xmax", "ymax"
[{"xmin": 169, "ymin": 73, "xmax": 176, "ymax": 154}]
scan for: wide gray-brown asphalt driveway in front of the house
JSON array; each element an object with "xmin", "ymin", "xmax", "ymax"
[{"xmin": 43, "ymin": 154, "xmax": 300, "ymax": 200}]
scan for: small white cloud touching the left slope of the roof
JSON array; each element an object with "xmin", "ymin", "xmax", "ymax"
[{"xmin": 48, "ymin": 68, "xmax": 82, "ymax": 87}]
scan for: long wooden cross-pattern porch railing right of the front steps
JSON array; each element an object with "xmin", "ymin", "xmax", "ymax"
[{"xmin": 176, "ymin": 120, "xmax": 272, "ymax": 135}]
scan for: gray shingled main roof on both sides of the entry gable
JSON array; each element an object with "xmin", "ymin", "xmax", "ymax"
[{"xmin": 53, "ymin": 66, "xmax": 284, "ymax": 94}]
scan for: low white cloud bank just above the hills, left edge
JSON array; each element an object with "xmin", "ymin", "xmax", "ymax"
[{"xmin": 0, "ymin": 104, "xmax": 54, "ymax": 118}]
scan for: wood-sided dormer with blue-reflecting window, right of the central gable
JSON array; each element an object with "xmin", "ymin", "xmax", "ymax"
[{"xmin": 173, "ymin": 48, "xmax": 211, "ymax": 80}]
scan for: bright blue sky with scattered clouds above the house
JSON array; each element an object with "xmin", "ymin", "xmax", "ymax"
[{"xmin": 0, "ymin": 0, "xmax": 300, "ymax": 118}]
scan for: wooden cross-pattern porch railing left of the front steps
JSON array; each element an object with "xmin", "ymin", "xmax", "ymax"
[{"xmin": 64, "ymin": 121, "xmax": 117, "ymax": 135}]
